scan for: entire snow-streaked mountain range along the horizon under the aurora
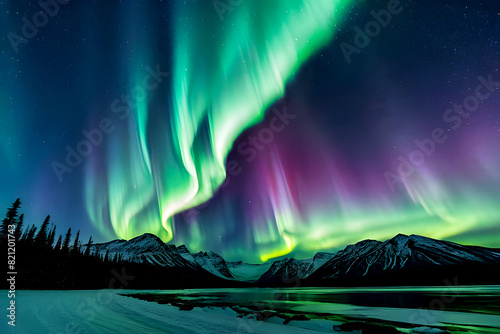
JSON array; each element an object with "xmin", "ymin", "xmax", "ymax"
[{"xmin": 86, "ymin": 233, "xmax": 500, "ymax": 284}]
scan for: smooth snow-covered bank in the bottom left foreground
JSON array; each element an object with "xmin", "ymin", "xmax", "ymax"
[{"xmin": 0, "ymin": 290, "xmax": 339, "ymax": 334}]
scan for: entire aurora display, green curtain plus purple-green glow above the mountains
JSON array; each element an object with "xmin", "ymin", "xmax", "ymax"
[{"xmin": 85, "ymin": 0, "xmax": 500, "ymax": 262}]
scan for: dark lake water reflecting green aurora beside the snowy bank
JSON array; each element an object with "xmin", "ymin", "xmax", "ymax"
[{"xmin": 125, "ymin": 282, "xmax": 500, "ymax": 333}]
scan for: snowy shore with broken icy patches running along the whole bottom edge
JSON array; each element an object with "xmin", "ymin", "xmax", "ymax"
[{"xmin": 0, "ymin": 289, "xmax": 500, "ymax": 334}]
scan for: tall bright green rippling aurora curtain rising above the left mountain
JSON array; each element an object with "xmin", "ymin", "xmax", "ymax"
[{"xmin": 85, "ymin": 0, "xmax": 351, "ymax": 245}]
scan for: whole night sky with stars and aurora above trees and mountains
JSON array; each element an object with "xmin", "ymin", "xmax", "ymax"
[{"xmin": 0, "ymin": 0, "xmax": 500, "ymax": 263}]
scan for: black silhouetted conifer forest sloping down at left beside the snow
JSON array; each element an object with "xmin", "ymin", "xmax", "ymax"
[{"xmin": 0, "ymin": 200, "xmax": 246, "ymax": 290}]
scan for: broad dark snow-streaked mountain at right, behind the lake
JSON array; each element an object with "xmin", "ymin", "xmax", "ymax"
[{"xmin": 310, "ymin": 234, "xmax": 500, "ymax": 279}]
